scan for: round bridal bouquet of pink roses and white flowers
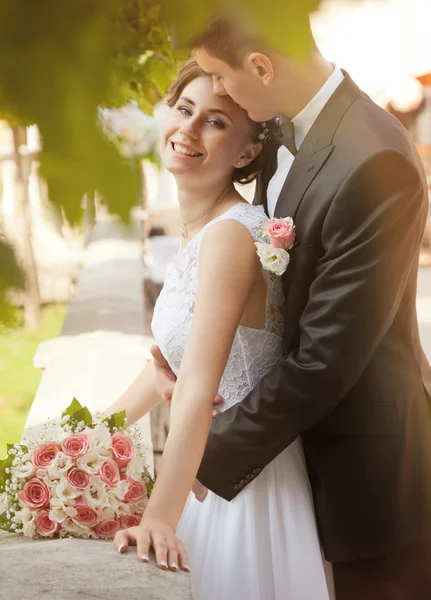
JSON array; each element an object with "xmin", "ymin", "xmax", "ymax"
[{"xmin": 0, "ymin": 399, "xmax": 153, "ymax": 538}]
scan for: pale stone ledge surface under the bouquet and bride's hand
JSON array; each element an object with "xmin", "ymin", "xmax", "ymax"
[{"xmin": 0, "ymin": 532, "xmax": 192, "ymax": 600}]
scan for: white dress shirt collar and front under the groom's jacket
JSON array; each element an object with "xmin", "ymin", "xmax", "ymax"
[{"xmin": 267, "ymin": 67, "xmax": 344, "ymax": 217}]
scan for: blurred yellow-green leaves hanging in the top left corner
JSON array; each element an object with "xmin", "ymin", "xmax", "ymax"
[{"xmin": 0, "ymin": 0, "xmax": 179, "ymax": 222}]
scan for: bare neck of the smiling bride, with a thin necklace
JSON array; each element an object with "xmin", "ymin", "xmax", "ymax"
[{"xmin": 177, "ymin": 181, "xmax": 234, "ymax": 237}]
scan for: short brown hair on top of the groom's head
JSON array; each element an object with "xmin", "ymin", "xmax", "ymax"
[{"xmin": 192, "ymin": 15, "xmax": 268, "ymax": 69}]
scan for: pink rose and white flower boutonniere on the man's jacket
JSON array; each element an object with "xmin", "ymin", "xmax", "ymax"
[{"xmin": 254, "ymin": 217, "xmax": 295, "ymax": 275}]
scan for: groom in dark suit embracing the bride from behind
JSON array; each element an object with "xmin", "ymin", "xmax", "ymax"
[{"xmin": 156, "ymin": 11, "xmax": 431, "ymax": 600}]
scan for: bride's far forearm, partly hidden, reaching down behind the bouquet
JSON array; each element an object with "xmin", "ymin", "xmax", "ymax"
[{"xmin": 105, "ymin": 360, "xmax": 161, "ymax": 424}]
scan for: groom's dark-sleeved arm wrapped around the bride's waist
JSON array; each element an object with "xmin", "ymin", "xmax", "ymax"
[{"xmin": 198, "ymin": 150, "xmax": 427, "ymax": 500}]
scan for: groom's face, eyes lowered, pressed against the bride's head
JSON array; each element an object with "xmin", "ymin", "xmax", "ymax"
[{"xmin": 194, "ymin": 48, "xmax": 278, "ymax": 122}]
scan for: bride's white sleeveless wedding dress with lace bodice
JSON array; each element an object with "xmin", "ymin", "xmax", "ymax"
[{"xmin": 152, "ymin": 203, "xmax": 335, "ymax": 600}]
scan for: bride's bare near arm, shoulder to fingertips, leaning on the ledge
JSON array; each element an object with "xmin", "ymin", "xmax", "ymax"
[{"xmin": 115, "ymin": 221, "xmax": 260, "ymax": 566}]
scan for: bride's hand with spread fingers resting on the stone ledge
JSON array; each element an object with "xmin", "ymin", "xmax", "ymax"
[{"xmin": 114, "ymin": 518, "xmax": 190, "ymax": 573}]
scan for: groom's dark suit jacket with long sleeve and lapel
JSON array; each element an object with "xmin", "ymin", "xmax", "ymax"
[{"xmin": 198, "ymin": 74, "xmax": 431, "ymax": 561}]
